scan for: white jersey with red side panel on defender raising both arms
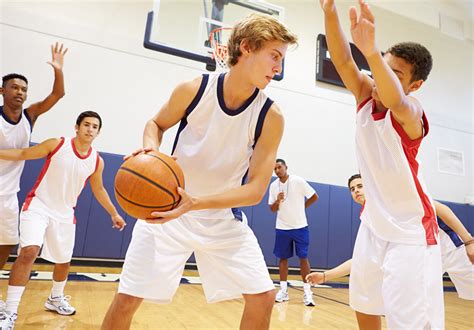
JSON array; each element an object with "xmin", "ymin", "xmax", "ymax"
[{"xmin": 356, "ymin": 98, "xmax": 438, "ymax": 245}]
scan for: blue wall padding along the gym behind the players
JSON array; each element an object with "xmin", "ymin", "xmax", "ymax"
[{"xmin": 18, "ymin": 153, "xmax": 474, "ymax": 268}]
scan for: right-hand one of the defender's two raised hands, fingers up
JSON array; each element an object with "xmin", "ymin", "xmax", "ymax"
[{"xmin": 349, "ymin": 0, "xmax": 378, "ymax": 57}]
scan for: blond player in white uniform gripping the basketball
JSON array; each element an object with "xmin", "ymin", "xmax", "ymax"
[{"xmin": 102, "ymin": 14, "xmax": 297, "ymax": 329}]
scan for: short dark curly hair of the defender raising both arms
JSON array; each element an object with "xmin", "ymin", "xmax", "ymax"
[{"xmin": 387, "ymin": 42, "xmax": 433, "ymax": 81}]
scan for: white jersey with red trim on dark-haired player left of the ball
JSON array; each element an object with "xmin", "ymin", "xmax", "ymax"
[{"xmin": 23, "ymin": 138, "xmax": 99, "ymax": 222}]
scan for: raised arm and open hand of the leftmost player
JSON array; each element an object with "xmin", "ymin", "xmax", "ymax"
[{"xmin": 26, "ymin": 43, "xmax": 68, "ymax": 124}]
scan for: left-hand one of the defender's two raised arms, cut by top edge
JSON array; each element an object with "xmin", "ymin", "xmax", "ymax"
[{"xmin": 319, "ymin": 0, "xmax": 373, "ymax": 104}]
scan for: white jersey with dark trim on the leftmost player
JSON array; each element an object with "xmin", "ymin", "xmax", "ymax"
[{"xmin": 0, "ymin": 106, "xmax": 32, "ymax": 196}]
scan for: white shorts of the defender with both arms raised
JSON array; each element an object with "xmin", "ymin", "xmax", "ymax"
[{"xmin": 349, "ymin": 223, "xmax": 444, "ymax": 329}]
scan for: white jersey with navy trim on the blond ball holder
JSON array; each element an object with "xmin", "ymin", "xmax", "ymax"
[{"xmin": 173, "ymin": 74, "xmax": 273, "ymax": 220}]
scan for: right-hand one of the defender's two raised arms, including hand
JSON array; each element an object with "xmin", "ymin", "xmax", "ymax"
[{"xmin": 349, "ymin": 0, "xmax": 423, "ymax": 134}]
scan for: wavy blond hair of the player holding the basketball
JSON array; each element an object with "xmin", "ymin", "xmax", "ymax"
[{"xmin": 227, "ymin": 14, "xmax": 298, "ymax": 67}]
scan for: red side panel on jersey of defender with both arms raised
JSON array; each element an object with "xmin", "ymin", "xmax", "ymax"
[{"xmin": 390, "ymin": 113, "xmax": 438, "ymax": 245}]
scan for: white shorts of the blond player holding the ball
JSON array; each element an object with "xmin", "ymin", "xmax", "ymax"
[{"xmin": 119, "ymin": 216, "xmax": 274, "ymax": 303}]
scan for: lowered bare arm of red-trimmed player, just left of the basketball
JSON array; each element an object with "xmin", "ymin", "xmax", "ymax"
[{"xmin": 90, "ymin": 157, "xmax": 127, "ymax": 231}]
